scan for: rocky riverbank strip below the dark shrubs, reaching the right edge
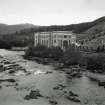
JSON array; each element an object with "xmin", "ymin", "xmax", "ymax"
[{"xmin": 25, "ymin": 57, "xmax": 105, "ymax": 87}]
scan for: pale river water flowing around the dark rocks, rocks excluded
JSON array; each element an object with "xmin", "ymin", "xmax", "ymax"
[{"xmin": 0, "ymin": 49, "xmax": 105, "ymax": 105}]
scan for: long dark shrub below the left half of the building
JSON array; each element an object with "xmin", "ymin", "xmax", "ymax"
[{"xmin": 25, "ymin": 44, "xmax": 63, "ymax": 60}]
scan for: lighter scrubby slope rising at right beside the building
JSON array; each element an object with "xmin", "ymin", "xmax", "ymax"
[{"xmin": 80, "ymin": 17, "xmax": 105, "ymax": 47}]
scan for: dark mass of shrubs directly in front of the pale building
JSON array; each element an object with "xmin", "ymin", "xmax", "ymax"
[{"xmin": 25, "ymin": 45, "xmax": 83, "ymax": 66}]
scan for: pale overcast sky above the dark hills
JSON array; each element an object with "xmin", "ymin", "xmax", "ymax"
[{"xmin": 0, "ymin": 0, "xmax": 105, "ymax": 26}]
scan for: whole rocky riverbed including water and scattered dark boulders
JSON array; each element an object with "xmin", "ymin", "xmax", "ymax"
[{"xmin": 0, "ymin": 49, "xmax": 105, "ymax": 105}]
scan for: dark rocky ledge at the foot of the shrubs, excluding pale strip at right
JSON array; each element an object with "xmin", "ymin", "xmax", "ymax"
[{"xmin": 23, "ymin": 56, "xmax": 85, "ymax": 78}]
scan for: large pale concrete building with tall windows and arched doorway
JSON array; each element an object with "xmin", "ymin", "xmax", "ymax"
[{"xmin": 34, "ymin": 31, "xmax": 76, "ymax": 48}]
